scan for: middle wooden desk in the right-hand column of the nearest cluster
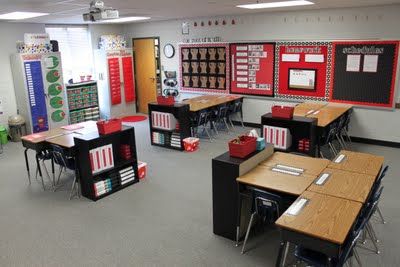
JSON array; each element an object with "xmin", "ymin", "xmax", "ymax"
[{"xmin": 307, "ymin": 168, "xmax": 376, "ymax": 203}]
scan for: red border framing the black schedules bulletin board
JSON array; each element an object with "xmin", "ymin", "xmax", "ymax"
[{"xmin": 329, "ymin": 40, "xmax": 400, "ymax": 108}]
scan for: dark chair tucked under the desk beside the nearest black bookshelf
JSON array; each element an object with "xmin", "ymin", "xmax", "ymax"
[{"xmin": 242, "ymin": 188, "xmax": 284, "ymax": 254}]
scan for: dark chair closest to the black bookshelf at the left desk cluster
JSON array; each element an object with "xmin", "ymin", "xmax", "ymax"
[{"xmin": 51, "ymin": 145, "xmax": 79, "ymax": 199}]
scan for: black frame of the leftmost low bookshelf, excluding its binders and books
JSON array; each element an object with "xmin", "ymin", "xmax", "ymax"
[{"xmin": 74, "ymin": 127, "xmax": 139, "ymax": 201}]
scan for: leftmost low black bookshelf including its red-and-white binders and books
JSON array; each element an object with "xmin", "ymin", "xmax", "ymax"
[{"xmin": 74, "ymin": 128, "xmax": 139, "ymax": 201}]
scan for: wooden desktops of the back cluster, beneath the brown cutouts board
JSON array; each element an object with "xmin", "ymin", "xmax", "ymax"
[{"xmin": 182, "ymin": 95, "xmax": 243, "ymax": 112}]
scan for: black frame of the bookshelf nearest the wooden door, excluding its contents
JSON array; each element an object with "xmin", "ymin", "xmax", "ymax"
[{"xmin": 149, "ymin": 103, "xmax": 190, "ymax": 151}]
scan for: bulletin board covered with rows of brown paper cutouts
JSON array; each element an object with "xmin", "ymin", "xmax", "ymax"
[{"xmin": 179, "ymin": 43, "xmax": 230, "ymax": 94}]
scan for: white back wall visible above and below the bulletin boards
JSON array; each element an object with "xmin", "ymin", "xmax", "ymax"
[{"xmin": 125, "ymin": 5, "xmax": 400, "ymax": 142}]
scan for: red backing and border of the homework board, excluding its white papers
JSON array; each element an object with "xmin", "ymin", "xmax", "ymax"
[{"xmin": 275, "ymin": 41, "xmax": 332, "ymax": 101}]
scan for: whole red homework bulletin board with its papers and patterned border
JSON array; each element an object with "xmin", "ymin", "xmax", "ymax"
[{"xmin": 275, "ymin": 42, "xmax": 332, "ymax": 101}]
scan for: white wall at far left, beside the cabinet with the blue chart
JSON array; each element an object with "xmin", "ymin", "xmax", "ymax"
[{"xmin": 0, "ymin": 22, "xmax": 44, "ymax": 125}]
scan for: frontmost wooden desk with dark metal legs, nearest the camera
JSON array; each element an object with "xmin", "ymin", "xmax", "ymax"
[{"xmin": 276, "ymin": 191, "xmax": 362, "ymax": 266}]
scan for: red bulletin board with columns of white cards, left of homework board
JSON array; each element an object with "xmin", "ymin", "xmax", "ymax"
[{"xmin": 230, "ymin": 43, "xmax": 275, "ymax": 96}]
